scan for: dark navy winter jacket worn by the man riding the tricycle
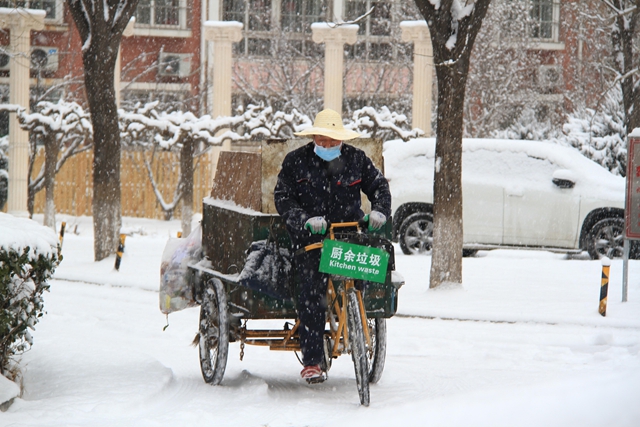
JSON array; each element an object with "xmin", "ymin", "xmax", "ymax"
[{"xmin": 273, "ymin": 142, "xmax": 391, "ymax": 249}]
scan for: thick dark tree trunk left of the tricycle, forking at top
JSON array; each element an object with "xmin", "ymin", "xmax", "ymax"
[{"xmin": 67, "ymin": 0, "xmax": 138, "ymax": 261}]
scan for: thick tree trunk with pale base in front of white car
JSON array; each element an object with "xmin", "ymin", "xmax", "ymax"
[{"xmin": 415, "ymin": 0, "xmax": 491, "ymax": 288}]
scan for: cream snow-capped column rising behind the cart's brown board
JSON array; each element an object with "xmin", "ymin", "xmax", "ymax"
[{"xmin": 202, "ymin": 21, "xmax": 242, "ymax": 177}]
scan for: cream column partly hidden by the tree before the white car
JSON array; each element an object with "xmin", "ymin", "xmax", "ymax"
[{"xmin": 400, "ymin": 21, "xmax": 433, "ymax": 136}]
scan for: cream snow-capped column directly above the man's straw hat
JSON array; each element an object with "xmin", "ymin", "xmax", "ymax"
[{"xmin": 311, "ymin": 22, "xmax": 358, "ymax": 114}]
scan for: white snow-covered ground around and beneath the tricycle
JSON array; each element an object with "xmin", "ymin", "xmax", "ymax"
[{"xmin": 0, "ymin": 216, "xmax": 640, "ymax": 427}]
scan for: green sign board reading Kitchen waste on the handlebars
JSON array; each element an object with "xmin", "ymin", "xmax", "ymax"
[{"xmin": 320, "ymin": 239, "xmax": 389, "ymax": 283}]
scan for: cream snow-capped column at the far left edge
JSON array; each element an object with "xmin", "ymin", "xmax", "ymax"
[{"xmin": 0, "ymin": 8, "xmax": 45, "ymax": 217}]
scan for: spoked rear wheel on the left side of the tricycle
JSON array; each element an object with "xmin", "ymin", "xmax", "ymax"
[{"xmin": 199, "ymin": 278, "xmax": 229, "ymax": 385}]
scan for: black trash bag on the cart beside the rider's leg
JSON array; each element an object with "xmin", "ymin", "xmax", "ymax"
[{"xmin": 238, "ymin": 239, "xmax": 292, "ymax": 300}]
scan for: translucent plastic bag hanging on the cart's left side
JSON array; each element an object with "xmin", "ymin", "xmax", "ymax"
[{"xmin": 160, "ymin": 224, "xmax": 202, "ymax": 314}]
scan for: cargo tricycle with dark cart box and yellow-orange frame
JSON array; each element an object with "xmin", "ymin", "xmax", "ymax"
[{"xmin": 188, "ymin": 198, "xmax": 403, "ymax": 406}]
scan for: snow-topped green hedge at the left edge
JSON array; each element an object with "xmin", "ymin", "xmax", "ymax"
[{"xmin": 0, "ymin": 212, "xmax": 62, "ymax": 379}]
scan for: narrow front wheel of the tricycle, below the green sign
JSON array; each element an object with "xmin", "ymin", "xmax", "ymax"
[{"xmin": 347, "ymin": 288, "xmax": 369, "ymax": 406}]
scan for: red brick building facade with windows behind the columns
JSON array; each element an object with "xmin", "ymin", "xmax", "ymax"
[{"xmin": 0, "ymin": 0, "xmax": 597, "ymax": 134}]
